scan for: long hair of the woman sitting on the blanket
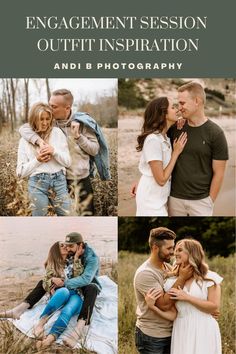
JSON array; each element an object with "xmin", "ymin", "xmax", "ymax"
[{"xmin": 44, "ymin": 241, "xmax": 65, "ymax": 278}]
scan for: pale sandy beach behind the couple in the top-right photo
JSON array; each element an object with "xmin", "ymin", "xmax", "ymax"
[{"xmin": 118, "ymin": 116, "xmax": 236, "ymax": 216}]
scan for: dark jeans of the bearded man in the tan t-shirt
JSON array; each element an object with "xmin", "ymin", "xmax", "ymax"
[{"xmin": 135, "ymin": 327, "xmax": 171, "ymax": 354}]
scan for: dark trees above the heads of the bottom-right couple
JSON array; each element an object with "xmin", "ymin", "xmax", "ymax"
[{"xmin": 118, "ymin": 217, "xmax": 235, "ymax": 257}]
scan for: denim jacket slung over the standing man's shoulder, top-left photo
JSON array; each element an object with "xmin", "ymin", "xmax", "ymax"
[{"xmin": 71, "ymin": 112, "xmax": 111, "ymax": 181}]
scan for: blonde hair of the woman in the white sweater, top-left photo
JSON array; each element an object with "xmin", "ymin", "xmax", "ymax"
[{"xmin": 28, "ymin": 102, "xmax": 53, "ymax": 140}]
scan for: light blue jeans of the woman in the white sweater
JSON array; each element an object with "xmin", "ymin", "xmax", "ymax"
[{"xmin": 28, "ymin": 171, "xmax": 71, "ymax": 216}]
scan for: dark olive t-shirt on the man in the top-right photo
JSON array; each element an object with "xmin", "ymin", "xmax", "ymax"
[{"xmin": 168, "ymin": 120, "xmax": 229, "ymax": 200}]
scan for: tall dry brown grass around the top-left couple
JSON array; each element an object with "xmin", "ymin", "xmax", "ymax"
[{"xmin": 0, "ymin": 128, "xmax": 118, "ymax": 216}]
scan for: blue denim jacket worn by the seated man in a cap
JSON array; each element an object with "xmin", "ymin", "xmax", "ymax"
[{"xmin": 65, "ymin": 244, "xmax": 102, "ymax": 290}]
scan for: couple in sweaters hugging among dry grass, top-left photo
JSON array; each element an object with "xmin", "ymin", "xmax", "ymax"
[{"xmin": 17, "ymin": 89, "xmax": 110, "ymax": 216}]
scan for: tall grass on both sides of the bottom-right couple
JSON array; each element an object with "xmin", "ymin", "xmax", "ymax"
[{"xmin": 118, "ymin": 251, "xmax": 236, "ymax": 354}]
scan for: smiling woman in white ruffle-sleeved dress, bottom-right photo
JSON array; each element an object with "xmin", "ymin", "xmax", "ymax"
[{"xmin": 146, "ymin": 239, "xmax": 223, "ymax": 354}]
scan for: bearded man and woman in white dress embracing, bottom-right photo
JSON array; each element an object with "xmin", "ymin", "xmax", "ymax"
[{"xmin": 134, "ymin": 227, "xmax": 223, "ymax": 354}]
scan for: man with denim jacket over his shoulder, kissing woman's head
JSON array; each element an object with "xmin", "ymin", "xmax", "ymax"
[{"xmin": 19, "ymin": 89, "xmax": 110, "ymax": 216}]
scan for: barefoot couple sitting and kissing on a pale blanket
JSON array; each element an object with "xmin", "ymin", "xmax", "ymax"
[{"xmin": 0, "ymin": 232, "xmax": 101, "ymax": 349}]
